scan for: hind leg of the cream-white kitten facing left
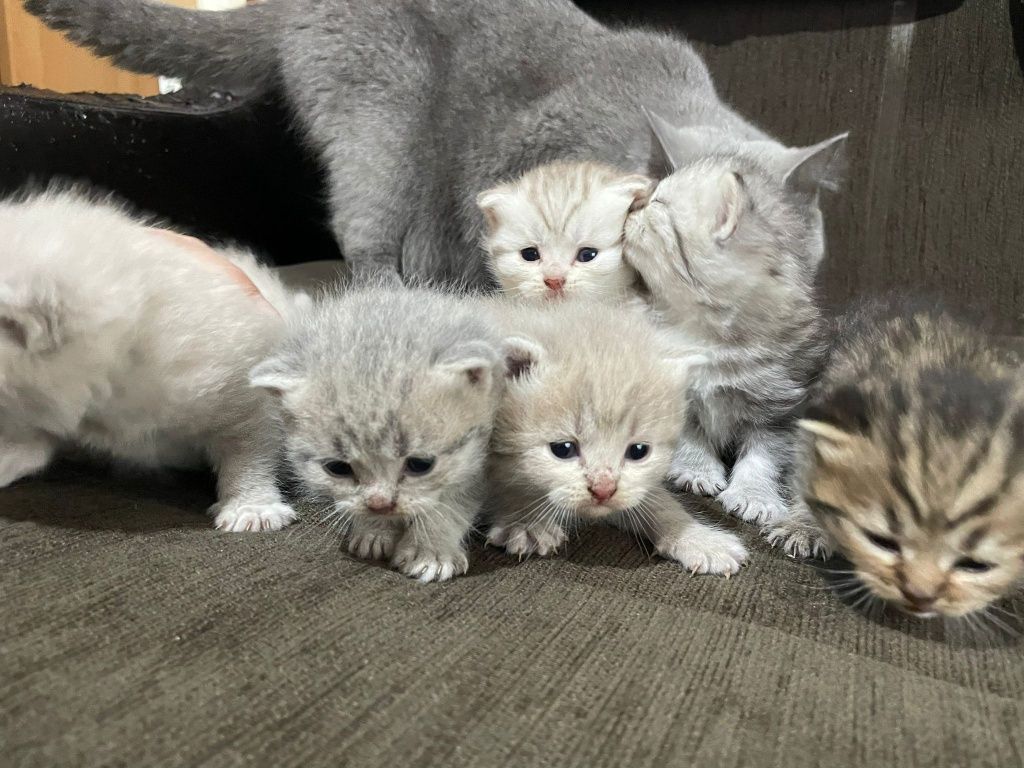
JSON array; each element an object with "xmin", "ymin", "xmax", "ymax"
[{"xmin": 210, "ymin": 425, "xmax": 296, "ymax": 532}]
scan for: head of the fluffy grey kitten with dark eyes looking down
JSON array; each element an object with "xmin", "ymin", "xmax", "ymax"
[{"xmin": 252, "ymin": 292, "xmax": 503, "ymax": 520}]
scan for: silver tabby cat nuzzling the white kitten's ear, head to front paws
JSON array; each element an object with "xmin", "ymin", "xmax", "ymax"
[{"xmin": 624, "ymin": 129, "xmax": 845, "ymax": 524}]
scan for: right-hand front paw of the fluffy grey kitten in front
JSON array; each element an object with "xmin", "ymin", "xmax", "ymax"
[{"xmin": 391, "ymin": 499, "xmax": 475, "ymax": 584}]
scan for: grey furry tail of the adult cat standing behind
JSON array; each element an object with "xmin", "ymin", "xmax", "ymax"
[{"xmin": 25, "ymin": 0, "xmax": 281, "ymax": 85}]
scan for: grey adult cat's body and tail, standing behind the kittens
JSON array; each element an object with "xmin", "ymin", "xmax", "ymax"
[{"xmin": 26, "ymin": 0, "xmax": 839, "ymax": 286}]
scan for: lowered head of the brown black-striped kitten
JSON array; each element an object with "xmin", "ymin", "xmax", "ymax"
[{"xmin": 801, "ymin": 370, "xmax": 1024, "ymax": 616}]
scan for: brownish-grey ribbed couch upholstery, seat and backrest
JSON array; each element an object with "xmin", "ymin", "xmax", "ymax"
[{"xmin": 0, "ymin": 0, "xmax": 1024, "ymax": 768}]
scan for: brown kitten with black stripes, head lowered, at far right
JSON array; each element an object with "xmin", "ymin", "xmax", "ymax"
[{"xmin": 773, "ymin": 302, "xmax": 1024, "ymax": 616}]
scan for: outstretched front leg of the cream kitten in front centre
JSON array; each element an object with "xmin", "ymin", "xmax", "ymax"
[{"xmin": 631, "ymin": 487, "xmax": 748, "ymax": 575}]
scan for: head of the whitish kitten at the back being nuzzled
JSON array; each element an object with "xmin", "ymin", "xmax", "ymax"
[{"xmin": 477, "ymin": 163, "xmax": 651, "ymax": 299}]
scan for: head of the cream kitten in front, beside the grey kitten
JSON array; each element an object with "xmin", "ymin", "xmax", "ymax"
[{"xmin": 493, "ymin": 301, "xmax": 688, "ymax": 518}]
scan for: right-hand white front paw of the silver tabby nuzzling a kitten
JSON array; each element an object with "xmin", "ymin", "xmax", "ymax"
[{"xmin": 718, "ymin": 428, "xmax": 793, "ymax": 525}]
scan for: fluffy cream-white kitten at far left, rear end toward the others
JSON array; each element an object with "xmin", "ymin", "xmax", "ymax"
[{"xmin": 0, "ymin": 190, "xmax": 302, "ymax": 530}]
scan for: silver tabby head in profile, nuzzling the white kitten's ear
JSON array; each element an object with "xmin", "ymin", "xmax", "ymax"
[{"xmin": 625, "ymin": 111, "xmax": 846, "ymax": 321}]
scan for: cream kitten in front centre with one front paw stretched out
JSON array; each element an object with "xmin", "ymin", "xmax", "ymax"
[{"xmin": 488, "ymin": 301, "xmax": 746, "ymax": 575}]
